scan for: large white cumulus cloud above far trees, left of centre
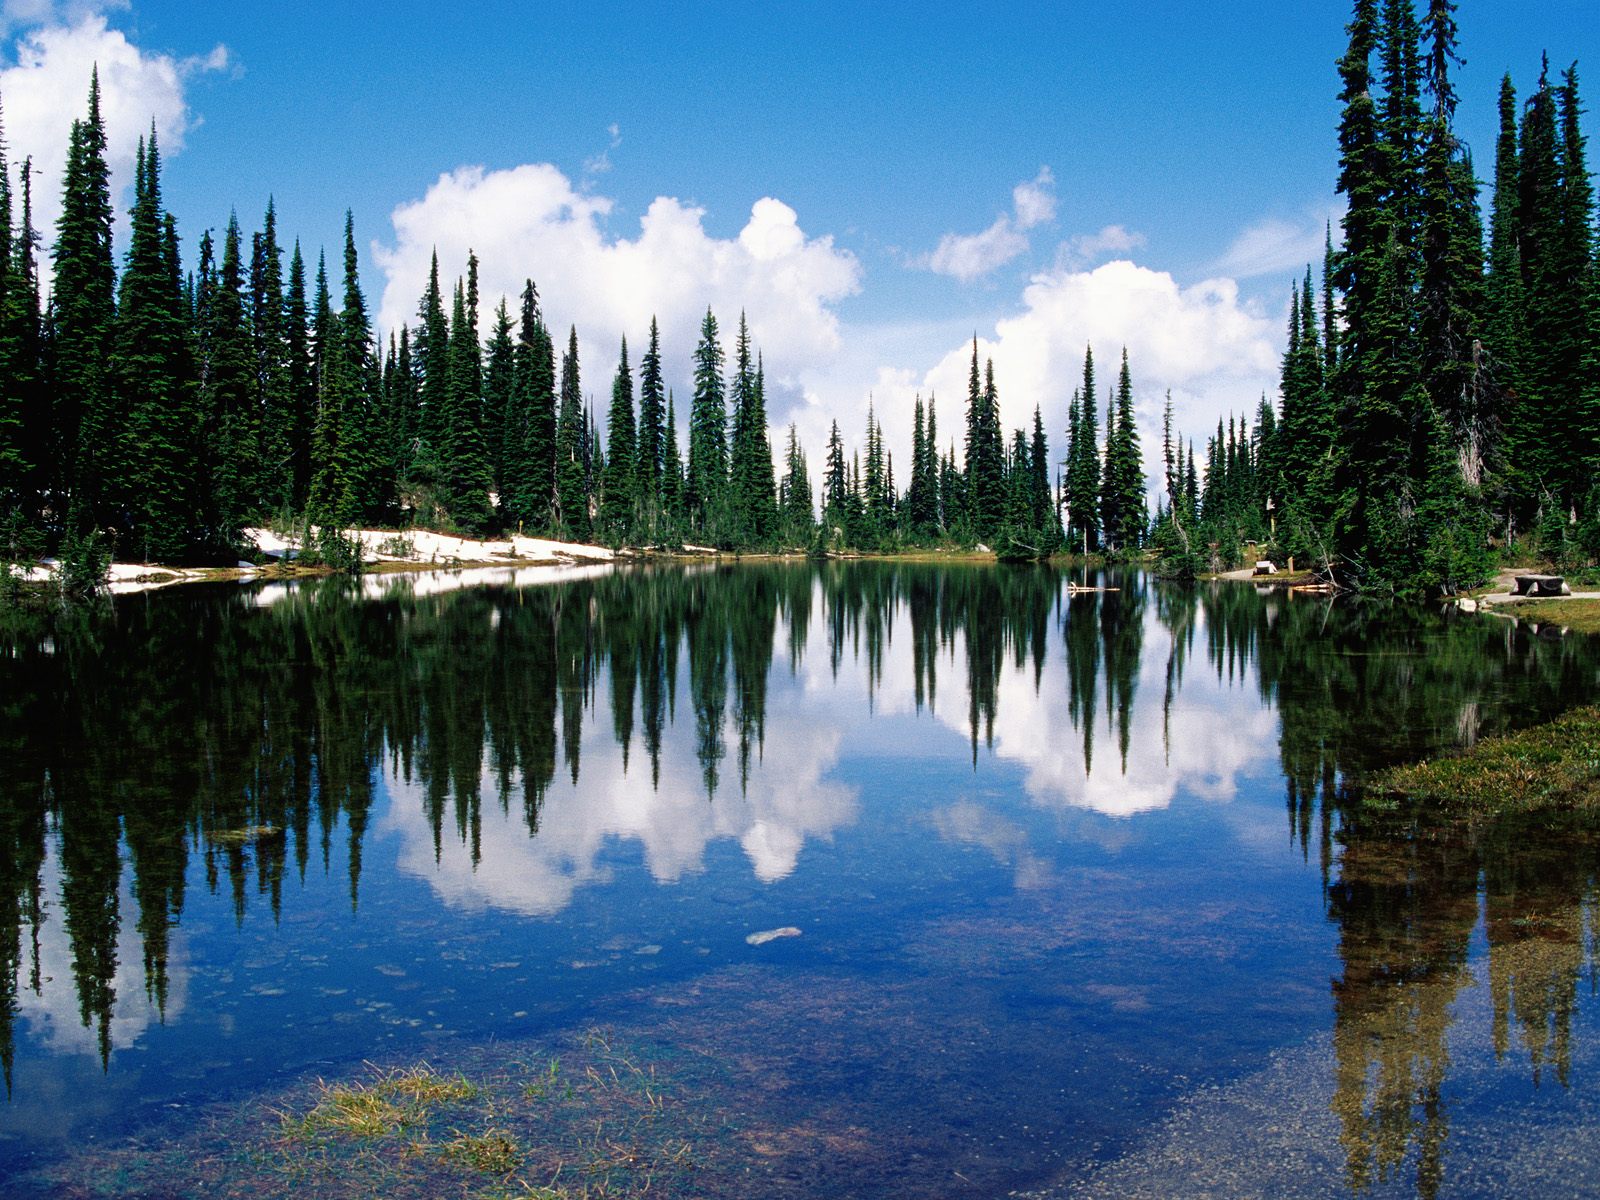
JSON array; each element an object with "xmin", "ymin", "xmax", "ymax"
[{"xmin": 376, "ymin": 163, "xmax": 861, "ymax": 392}]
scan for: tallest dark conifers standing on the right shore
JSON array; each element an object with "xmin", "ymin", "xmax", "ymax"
[{"xmin": 1157, "ymin": 0, "xmax": 1600, "ymax": 592}]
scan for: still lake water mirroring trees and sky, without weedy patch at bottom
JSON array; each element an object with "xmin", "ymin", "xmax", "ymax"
[{"xmin": 0, "ymin": 563, "xmax": 1600, "ymax": 1197}]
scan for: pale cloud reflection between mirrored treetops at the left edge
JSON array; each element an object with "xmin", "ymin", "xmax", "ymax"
[{"xmin": 16, "ymin": 840, "xmax": 189, "ymax": 1056}]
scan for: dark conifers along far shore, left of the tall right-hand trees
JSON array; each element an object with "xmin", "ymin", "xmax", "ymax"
[{"xmin": 0, "ymin": 72, "xmax": 1190, "ymax": 563}]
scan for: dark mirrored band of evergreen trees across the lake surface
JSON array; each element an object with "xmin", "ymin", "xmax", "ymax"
[{"xmin": 0, "ymin": 563, "xmax": 1594, "ymax": 1100}]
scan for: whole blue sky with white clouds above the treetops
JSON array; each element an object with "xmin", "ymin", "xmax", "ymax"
[{"xmin": 0, "ymin": 0, "xmax": 1600, "ymax": 480}]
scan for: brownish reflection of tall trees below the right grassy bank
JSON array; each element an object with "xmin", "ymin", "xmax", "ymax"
[{"xmin": 1328, "ymin": 813, "xmax": 1600, "ymax": 1197}]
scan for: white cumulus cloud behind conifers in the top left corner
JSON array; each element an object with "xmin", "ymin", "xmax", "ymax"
[{"xmin": 0, "ymin": 8, "xmax": 229, "ymax": 252}]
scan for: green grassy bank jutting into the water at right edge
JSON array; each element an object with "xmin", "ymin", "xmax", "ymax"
[{"xmin": 1366, "ymin": 707, "xmax": 1600, "ymax": 816}]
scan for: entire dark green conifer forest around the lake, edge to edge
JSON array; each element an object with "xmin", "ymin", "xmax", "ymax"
[{"xmin": 0, "ymin": 0, "xmax": 1600, "ymax": 592}]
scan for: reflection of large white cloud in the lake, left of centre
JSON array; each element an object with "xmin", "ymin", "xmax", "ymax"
[{"xmin": 379, "ymin": 672, "xmax": 856, "ymax": 915}]
